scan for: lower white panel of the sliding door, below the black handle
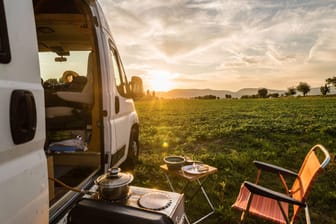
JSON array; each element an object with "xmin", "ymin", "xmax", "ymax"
[{"xmin": 0, "ymin": 149, "xmax": 49, "ymax": 224}]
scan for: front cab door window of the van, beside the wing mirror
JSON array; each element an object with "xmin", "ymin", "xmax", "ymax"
[{"xmin": 110, "ymin": 43, "xmax": 130, "ymax": 97}]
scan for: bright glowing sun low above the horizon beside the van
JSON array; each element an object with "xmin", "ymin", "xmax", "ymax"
[{"xmin": 148, "ymin": 71, "xmax": 176, "ymax": 92}]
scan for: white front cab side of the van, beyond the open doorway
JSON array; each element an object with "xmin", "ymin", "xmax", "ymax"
[{"xmin": 92, "ymin": 2, "xmax": 139, "ymax": 166}]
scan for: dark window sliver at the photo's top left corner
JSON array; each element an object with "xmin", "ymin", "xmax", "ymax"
[{"xmin": 0, "ymin": 0, "xmax": 11, "ymax": 63}]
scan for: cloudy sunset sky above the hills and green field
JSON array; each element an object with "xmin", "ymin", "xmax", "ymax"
[{"xmin": 99, "ymin": 0, "xmax": 336, "ymax": 91}]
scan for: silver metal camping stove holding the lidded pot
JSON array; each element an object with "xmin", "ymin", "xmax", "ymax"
[{"xmin": 86, "ymin": 186, "xmax": 185, "ymax": 224}]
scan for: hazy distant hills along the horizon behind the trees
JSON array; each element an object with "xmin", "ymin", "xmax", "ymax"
[{"xmin": 155, "ymin": 87, "xmax": 336, "ymax": 98}]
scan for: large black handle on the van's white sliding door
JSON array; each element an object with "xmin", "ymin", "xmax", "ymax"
[{"xmin": 10, "ymin": 90, "xmax": 36, "ymax": 144}]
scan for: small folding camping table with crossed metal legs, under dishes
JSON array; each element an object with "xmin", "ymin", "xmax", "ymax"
[{"xmin": 160, "ymin": 164, "xmax": 217, "ymax": 224}]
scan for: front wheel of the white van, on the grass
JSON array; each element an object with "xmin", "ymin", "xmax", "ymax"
[{"xmin": 123, "ymin": 129, "xmax": 139, "ymax": 170}]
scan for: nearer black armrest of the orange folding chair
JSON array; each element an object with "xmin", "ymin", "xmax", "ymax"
[{"xmin": 244, "ymin": 181, "xmax": 306, "ymax": 207}]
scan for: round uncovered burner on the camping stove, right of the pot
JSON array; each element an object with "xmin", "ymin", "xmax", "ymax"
[{"xmin": 138, "ymin": 192, "xmax": 172, "ymax": 211}]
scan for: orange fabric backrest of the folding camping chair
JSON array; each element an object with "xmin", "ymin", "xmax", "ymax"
[{"xmin": 291, "ymin": 145, "xmax": 330, "ymax": 221}]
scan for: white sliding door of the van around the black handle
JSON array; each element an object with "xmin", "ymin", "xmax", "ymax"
[{"xmin": 0, "ymin": 0, "xmax": 49, "ymax": 223}]
